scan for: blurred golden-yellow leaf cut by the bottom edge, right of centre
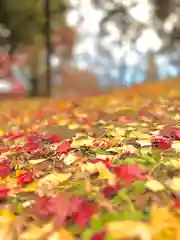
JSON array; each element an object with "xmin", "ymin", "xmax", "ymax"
[{"xmin": 107, "ymin": 220, "xmax": 152, "ymax": 240}]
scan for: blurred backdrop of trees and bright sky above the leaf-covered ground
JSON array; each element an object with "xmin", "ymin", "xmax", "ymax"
[{"xmin": 0, "ymin": 0, "xmax": 180, "ymax": 98}]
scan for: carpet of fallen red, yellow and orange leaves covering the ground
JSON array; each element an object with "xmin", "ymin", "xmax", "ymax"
[{"xmin": 0, "ymin": 84, "xmax": 180, "ymax": 240}]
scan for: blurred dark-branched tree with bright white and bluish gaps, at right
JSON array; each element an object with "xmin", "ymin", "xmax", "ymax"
[{"xmin": 67, "ymin": 0, "xmax": 180, "ymax": 85}]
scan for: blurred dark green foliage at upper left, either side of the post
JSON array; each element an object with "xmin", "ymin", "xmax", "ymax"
[{"xmin": 0, "ymin": 0, "xmax": 65, "ymax": 43}]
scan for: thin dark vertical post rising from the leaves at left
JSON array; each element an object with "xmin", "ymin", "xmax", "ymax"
[{"xmin": 44, "ymin": 0, "xmax": 51, "ymax": 97}]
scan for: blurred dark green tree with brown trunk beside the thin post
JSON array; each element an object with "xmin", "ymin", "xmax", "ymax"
[{"xmin": 0, "ymin": 0, "xmax": 66, "ymax": 95}]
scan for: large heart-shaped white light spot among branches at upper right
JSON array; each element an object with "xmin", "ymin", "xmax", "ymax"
[{"xmin": 136, "ymin": 29, "xmax": 163, "ymax": 53}]
